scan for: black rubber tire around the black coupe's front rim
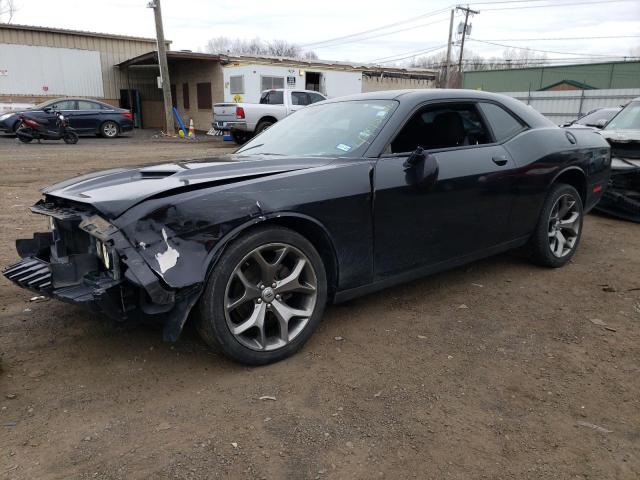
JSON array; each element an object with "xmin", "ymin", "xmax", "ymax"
[{"xmin": 196, "ymin": 227, "xmax": 327, "ymax": 365}]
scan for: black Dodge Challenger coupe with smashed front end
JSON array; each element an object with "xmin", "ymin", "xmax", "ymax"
[{"xmin": 4, "ymin": 90, "xmax": 611, "ymax": 364}]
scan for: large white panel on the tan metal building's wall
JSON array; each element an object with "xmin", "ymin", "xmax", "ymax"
[{"xmin": 0, "ymin": 43, "xmax": 104, "ymax": 97}]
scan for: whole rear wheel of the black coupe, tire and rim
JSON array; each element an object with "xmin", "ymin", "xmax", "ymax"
[{"xmin": 530, "ymin": 183, "xmax": 583, "ymax": 268}]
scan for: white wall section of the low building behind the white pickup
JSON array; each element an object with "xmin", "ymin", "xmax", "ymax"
[{"xmin": 223, "ymin": 64, "xmax": 362, "ymax": 103}]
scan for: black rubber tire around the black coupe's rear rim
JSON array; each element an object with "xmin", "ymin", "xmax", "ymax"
[{"xmin": 529, "ymin": 183, "xmax": 584, "ymax": 268}]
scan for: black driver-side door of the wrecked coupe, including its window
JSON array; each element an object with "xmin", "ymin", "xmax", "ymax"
[{"xmin": 374, "ymin": 102, "xmax": 515, "ymax": 279}]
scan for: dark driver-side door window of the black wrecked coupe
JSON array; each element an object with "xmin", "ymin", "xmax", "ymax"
[{"xmin": 391, "ymin": 103, "xmax": 493, "ymax": 153}]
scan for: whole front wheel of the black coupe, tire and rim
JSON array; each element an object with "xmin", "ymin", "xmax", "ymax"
[{"xmin": 197, "ymin": 227, "xmax": 327, "ymax": 365}]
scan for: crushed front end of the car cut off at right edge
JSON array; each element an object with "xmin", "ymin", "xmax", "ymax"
[{"xmin": 596, "ymin": 131, "xmax": 640, "ymax": 223}]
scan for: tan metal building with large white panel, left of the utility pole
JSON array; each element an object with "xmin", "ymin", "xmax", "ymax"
[{"xmin": 0, "ymin": 24, "xmax": 168, "ymax": 127}]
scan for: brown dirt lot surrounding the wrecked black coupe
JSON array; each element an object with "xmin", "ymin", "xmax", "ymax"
[{"xmin": 0, "ymin": 129, "xmax": 640, "ymax": 479}]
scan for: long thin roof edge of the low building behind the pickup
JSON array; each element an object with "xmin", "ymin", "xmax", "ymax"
[{"xmin": 116, "ymin": 50, "xmax": 436, "ymax": 78}]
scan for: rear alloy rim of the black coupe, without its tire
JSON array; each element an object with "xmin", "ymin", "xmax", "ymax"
[{"xmin": 548, "ymin": 193, "xmax": 580, "ymax": 258}]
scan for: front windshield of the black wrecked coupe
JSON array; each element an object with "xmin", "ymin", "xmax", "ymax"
[{"xmin": 236, "ymin": 100, "xmax": 398, "ymax": 157}]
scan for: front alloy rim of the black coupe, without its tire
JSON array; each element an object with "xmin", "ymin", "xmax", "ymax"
[{"xmin": 224, "ymin": 243, "xmax": 318, "ymax": 351}]
